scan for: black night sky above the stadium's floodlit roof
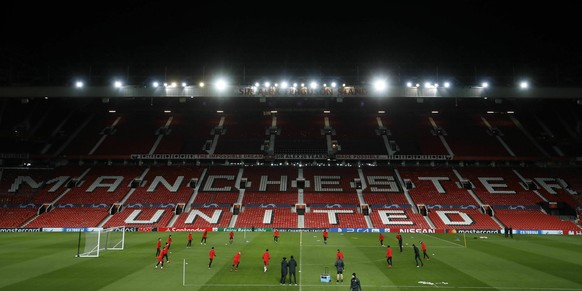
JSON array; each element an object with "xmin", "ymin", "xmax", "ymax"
[{"xmin": 0, "ymin": 0, "xmax": 582, "ymax": 84}]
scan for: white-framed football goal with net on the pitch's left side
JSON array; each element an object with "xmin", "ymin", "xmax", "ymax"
[{"xmin": 77, "ymin": 226, "xmax": 125, "ymax": 258}]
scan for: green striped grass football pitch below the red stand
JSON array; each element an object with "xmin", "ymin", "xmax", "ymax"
[{"xmin": 0, "ymin": 232, "xmax": 582, "ymax": 291}]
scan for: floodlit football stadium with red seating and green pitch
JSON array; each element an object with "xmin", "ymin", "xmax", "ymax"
[{"xmin": 0, "ymin": 77, "xmax": 582, "ymax": 290}]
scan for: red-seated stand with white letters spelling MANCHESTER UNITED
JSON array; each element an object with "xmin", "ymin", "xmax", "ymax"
[{"xmin": 0, "ymin": 97, "xmax": 582, "ymax": 231}]
